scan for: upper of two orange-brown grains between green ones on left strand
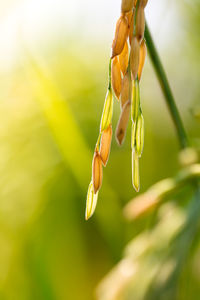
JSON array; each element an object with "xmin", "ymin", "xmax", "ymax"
[{"xmin": 100, "ymin": 125, "xmax": 112, "ymax": 166}]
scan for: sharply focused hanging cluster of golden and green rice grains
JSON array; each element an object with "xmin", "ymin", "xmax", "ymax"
[{"xmin": 85, "ymin": 0, "xmax": 148, "ymax": 219}]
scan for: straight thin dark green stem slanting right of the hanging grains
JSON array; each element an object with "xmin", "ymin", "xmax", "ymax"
[{"xmin": 145, "ymin": 24, "xmax": 189, "ymax": 148}]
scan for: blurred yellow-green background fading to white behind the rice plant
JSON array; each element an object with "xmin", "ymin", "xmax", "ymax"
[{"xmin": 0, "ymin": 0, "xmax": 200, "ymax": 300}]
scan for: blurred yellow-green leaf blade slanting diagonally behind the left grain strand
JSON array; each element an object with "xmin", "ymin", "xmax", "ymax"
[{"xmin": 26, "ymin": 54, "xmax": 123, "ymax": 260}]
